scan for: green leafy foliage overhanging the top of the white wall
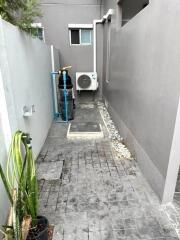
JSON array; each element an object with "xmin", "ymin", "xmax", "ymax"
[{"xmin": 0, "ymin": 0, "xmax": 41, "ymax": 32}]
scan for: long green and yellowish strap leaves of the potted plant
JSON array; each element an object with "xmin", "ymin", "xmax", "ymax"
[{"xmin": 0, "ymin": 131, "xmax": 38, "ymax": 240}]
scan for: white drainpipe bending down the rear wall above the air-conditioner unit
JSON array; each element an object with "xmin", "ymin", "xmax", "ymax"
[{"xmin": 93, "ymin": 9, "xmax": 114, "ymax": 73}]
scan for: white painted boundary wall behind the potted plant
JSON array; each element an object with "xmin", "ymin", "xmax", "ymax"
[{"xmin": 0, "ymin": 19, "xmax": 59, "ymax": 224}]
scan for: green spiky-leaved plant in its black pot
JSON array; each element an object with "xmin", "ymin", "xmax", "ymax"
[{"xmin": 0, "ymin": 131, "xmax": 48, "ymax": 240}]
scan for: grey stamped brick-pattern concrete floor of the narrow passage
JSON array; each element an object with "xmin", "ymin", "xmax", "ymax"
[{"xmin": 37, "ymin": 101, "xmax": 180, "ymax": 240}]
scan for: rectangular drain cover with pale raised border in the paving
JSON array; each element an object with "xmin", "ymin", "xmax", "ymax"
[{"xmin": 67, "ymin": 122, "xmax": 104, "ymax": 138}]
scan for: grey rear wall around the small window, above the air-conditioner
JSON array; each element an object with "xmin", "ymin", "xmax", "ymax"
[{"xmin": 39, "ymin": 0, "xmax": 103, "ymax": 99}]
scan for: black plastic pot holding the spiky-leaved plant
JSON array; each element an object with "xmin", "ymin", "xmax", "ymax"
[{"xmin": 27, "ymin": 216, "xmax": 49, "ymax": 240}]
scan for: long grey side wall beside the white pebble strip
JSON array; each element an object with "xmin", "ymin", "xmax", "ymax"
[{"xmin": 103, "ymin": 0, "xmax": 180, "ymax": 201}]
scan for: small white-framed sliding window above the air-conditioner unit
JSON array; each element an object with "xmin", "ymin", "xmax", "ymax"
[{"xmin": 70, "ymin": 29, "xmax": 92, "ymax": 45}]
